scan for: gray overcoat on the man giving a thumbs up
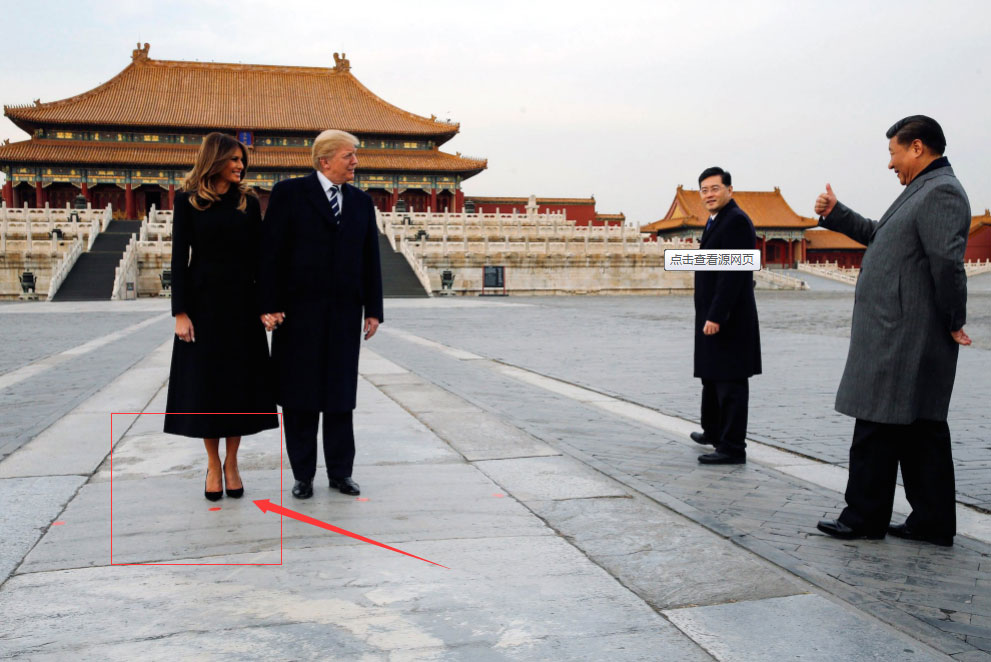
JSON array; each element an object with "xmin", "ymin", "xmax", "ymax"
[{"xmin": 819, "ymin": 166, "xmax": 971, "ymax": 424}]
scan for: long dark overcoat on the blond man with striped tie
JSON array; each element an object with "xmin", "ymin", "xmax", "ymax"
[{"xmin": 259, "ymin": 172, "xmax": 384, "ymax": 412}]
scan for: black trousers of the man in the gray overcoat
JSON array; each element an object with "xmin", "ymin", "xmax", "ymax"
[{"xmin": 840, "ymin": 418, "xmax": 957, "ymax": 536}]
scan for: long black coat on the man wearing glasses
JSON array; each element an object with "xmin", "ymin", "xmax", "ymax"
[{"xmin": 695, "ymin": 200, "xmax": 761, "ymax": 380}]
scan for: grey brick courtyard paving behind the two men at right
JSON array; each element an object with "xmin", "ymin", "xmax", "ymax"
[{"xmin": 374, "ymin": 288, "xmax": 991, "ymax": 510}]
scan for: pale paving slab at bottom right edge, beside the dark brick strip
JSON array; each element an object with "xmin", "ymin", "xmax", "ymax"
[{"xmin": 664, "ymin": 595, "xmax": 947, "ymax": 662}]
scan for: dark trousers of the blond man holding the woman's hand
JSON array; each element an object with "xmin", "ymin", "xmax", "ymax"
[{"xmin": 282, "ymin": 407, "xmax": 354, "ymax": 481}]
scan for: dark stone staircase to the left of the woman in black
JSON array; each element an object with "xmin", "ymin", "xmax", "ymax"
[{"xmin": 52, "ymin": 221, "xmax": 141, "ymax": 301}]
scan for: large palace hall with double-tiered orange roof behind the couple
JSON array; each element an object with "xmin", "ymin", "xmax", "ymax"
[{"xmin": 0, "ymin": 44, "xmax": 487, "ymax": 219}]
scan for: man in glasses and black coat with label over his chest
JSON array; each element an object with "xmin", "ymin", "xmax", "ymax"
[{"xmin": 691, "ymin": 168, "xmax": 761, "ymax": 464}]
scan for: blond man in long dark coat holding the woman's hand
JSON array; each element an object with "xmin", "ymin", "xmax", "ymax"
[{"xmin": 258, "ymin": 130, "xmax": 382, "ymax": 499}]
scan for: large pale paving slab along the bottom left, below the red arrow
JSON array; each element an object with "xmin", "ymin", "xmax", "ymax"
[{"xmin": 0, "ymin": 537, "xmax": 712, "ymax": 662}]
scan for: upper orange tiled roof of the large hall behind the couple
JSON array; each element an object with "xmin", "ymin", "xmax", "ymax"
[{"xmin": 4, "ymin": 44, "xmax": 458, "ymax": 142}]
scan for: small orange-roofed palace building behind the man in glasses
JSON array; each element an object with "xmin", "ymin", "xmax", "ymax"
[{"xmin": 640, "ymin": 186, "xmax": 818, "ymax": 266}]
